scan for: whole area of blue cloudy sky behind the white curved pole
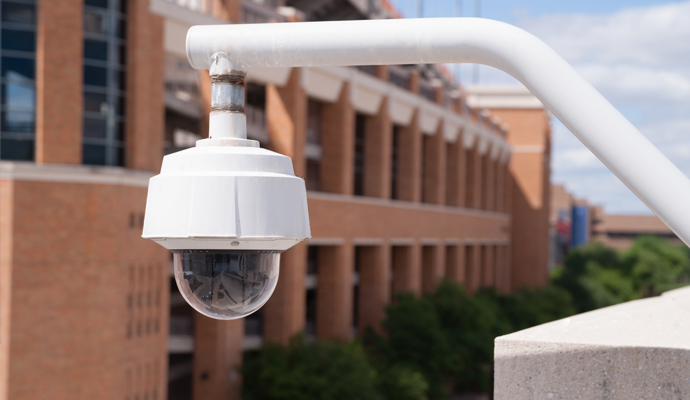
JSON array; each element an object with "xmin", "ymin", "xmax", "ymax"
[{"xmin": 391, "ymin": 0, "xmax": 690, "ymax": 214}]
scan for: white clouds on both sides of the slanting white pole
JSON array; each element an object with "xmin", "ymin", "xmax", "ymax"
[{"xmin": 508, "ymin": 1, "xmax": 690, "ymax": 213}]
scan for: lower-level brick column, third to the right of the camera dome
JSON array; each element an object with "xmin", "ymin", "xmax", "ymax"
[{"xmin": 357, "ymin": 245, "xmax": 391, "ymax": 333}]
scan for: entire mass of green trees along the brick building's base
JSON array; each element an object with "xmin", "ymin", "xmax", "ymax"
[{"xmin": 243, "ymin": 237, "xmax": 690, "ymax": 400}]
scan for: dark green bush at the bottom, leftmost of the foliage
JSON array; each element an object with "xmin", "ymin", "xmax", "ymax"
[{"xmin": 242, "ymin": 336, "xmax": 382, "ymax": 400}]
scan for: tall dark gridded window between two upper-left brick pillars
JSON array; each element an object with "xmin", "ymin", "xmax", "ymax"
[{"xmin": 82, "ymin": 0, "xmax": 127, "ymax": 166}]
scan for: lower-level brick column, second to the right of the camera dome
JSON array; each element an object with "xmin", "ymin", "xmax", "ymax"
[{"xmin": 316, "ymin": 243, "xmax": 354, "ymax": 341}]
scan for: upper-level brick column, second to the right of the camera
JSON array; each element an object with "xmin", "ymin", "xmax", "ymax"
[{"xmin": 321, "ymin": 83, "xmax": 355, "ymax": 194}]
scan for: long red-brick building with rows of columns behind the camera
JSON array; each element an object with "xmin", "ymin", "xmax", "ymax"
[{"xmin": 0, "ymin": 0, "xmax": 550, "ymax": 400}]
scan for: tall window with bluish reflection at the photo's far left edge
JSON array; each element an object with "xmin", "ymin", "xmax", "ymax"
[{"xmin": 0, "ymin": 0, "xmax": 36, "ymax": 161}]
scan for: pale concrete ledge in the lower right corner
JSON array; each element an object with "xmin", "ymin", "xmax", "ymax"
[{"xmin": 494, "ymin": 287, "xmax": 690, "ymax": 400}]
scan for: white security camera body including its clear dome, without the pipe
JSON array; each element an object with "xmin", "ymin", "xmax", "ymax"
[{"xmin": 142, "ymin": 139, "xmax": 311, "ymax": 319}]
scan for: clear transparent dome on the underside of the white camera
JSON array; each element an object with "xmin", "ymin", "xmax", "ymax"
[{"xmin": 173, "ymin": 250, "xmax": 280, "ymax": 320}]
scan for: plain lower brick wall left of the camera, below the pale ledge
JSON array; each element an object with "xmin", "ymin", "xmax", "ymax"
[{"xmin": 0, "ymin": 181, "xmax": 169, "ymax": 400}]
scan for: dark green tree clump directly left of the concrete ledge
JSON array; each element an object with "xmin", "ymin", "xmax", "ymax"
[{"xmin": 364, "ymin": 281, "xmax": 573, "ymax": 399}]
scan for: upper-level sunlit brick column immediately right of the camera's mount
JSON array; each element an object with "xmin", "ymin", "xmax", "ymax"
[{"xmin": 266, "ymin": 68, "xmax": 307, "ymax": 176}]
